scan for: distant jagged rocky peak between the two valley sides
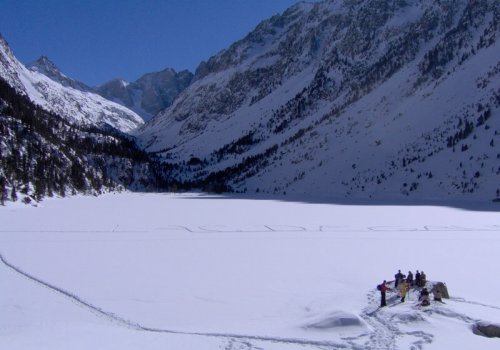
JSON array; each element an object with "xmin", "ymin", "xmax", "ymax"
[{"xmin": 96, "ymin": 68, "xmax": 193, "ymax": 120}]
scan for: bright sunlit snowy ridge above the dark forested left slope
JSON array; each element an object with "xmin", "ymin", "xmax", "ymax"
[{"xmin": 0, "ymin": 37, "xmax": 143, "ymax": 131}]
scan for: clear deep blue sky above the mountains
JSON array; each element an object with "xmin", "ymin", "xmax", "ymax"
[{"xmin": 0, "ymin": 0, "xmax": 308, "ymax": 86}]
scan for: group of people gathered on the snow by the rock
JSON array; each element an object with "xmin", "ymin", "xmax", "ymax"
[{"xmin": 377, "ymin": 270, "xmax": 430, "ymax": 307}]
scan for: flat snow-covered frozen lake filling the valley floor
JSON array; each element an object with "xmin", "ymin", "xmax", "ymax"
[{"xmin": 0, "ymin": 193, "xmax": 500, "ymax": 350}]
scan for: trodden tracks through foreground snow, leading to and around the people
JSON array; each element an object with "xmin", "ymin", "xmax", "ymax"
[{"xmin": 0, "ymin": 253, "xmax": 500, "ymax": 350}]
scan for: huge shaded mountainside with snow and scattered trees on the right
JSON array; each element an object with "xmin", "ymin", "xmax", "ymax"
[{"xmin": 136, "ymin": 0, "xmax": 500, "ymax": 200}]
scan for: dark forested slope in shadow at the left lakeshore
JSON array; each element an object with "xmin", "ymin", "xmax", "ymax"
[{"xmin": 0, "ymin": 78, "xmax": 172, "ymax": 202}]
